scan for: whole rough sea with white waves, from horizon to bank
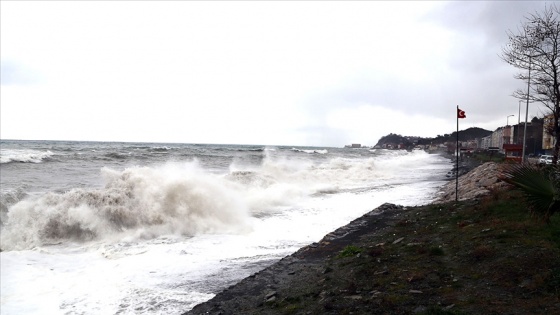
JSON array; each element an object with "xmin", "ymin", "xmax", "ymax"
[{"xmin": 0, "ymin": 140, "xmax": 452, "ymax": 314}]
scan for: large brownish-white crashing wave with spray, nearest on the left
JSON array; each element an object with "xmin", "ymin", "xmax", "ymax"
[{"xmin": 2, "ymin": 162, "xmax": 250, "ymax": 250}]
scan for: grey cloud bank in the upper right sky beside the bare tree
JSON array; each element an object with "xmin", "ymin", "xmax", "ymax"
[{"xmin": 328, "ymin": 1, "xmax": 545, "ymax": 119}]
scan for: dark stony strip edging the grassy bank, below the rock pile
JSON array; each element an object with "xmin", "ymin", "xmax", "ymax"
[{"xmin": 183, "ymin": 203, "xmax": 406, "ymax": 315}]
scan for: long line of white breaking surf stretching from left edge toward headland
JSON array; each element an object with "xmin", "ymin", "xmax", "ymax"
[{"xmin": 1, "ymin": 152, "xmax": 442, "ymax": 250}]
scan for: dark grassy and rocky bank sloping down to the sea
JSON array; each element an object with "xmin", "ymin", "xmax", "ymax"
[{"xmin": 185, "ymin": 163, "xmax": 560, "ymax": 314}]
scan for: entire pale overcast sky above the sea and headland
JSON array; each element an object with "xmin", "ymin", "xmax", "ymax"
[{"xmin": 0, "ymin": 1, "xmax": 546, "ymax": 147}]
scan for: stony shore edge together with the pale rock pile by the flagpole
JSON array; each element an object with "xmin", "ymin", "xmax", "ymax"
[{"xmin": 183, "ymin": 159, "xmax": 500, "ymax": 315}]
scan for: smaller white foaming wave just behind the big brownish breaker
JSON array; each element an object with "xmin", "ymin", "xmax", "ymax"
[{"xmin": 225, "ymin": 155, "xmax": 387, "ymax": 213}]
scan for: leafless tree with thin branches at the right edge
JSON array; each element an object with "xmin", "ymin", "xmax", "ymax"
[{"xmin": 500, "ymin": 4, "xmax": 560, "ymax": 164}]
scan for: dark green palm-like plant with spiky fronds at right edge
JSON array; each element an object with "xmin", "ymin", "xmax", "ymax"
[{"xmin": 501, "ymin": 164, "xmax": 560, "ymax": 223}]
